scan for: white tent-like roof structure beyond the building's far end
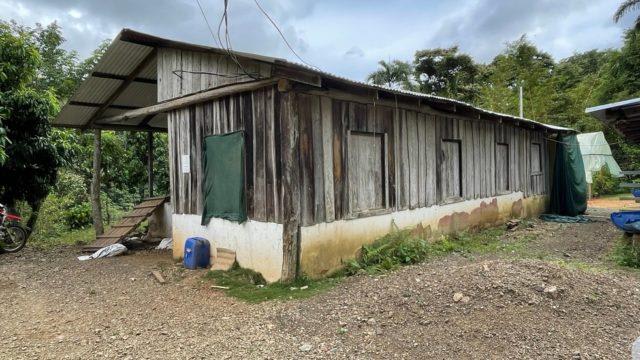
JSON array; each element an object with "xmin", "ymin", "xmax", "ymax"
[{"xmin": 578, "ymin": 131, "xmax": 623, "ymax": 184}]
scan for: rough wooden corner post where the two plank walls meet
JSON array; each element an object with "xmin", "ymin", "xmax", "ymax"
[{"xmin": 280, "ymin": 91, "xmax": 300, "ymax": 282}]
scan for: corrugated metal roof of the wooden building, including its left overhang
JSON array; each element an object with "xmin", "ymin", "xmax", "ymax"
[{"xmin": 54, "ymin": 29, "xmax": 574, "ymax": 131}]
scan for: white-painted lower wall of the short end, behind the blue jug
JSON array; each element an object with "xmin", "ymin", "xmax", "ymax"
[{"xmin": 172, "ymin": 214, "xmax": 282, "ymax": 282}]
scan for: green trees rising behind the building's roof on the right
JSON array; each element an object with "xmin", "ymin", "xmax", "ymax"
[{"xmin": 369, "ymin": 23, "xmax": 640, "ymax": 173}]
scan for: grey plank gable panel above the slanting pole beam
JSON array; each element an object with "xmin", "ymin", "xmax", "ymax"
[{"xmin": 157, "ymin": 48, "xmax": 271, "ymax": 102}]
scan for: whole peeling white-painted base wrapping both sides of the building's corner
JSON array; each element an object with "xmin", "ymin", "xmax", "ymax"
[{"xmin": 172, "ymin": 192, "xmax": 548, "ymax": 282}]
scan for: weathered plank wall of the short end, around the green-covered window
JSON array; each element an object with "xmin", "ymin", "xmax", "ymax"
[{"xmin": 168, "ymin": 87, "xmax": 281, "ymax": 222}]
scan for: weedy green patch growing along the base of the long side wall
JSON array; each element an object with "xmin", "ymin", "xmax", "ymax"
[{"xmin": 345, "ymin": 227, "xmax": 532, "ymax": 275}]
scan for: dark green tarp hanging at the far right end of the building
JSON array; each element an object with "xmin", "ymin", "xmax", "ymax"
[{"xmin": 551, "ymin": 134, "xmax": 587, "ymax": 216}]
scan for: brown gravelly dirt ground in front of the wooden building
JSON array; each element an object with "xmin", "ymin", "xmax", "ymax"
[{"xmin": 0, "ymin": 209, "xmax": 640, "ymax": 359}]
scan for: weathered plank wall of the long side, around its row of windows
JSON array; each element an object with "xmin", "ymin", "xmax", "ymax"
[{"xmin": 298, "ymin": 93, "xmax": 548, "ymax": 226}]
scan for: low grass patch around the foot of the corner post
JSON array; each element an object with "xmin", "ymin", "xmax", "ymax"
[{"xmin": 204, "ymin": 264, "xmax": 342, "ymax": 303}]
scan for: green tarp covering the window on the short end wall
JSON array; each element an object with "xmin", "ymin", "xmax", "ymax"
[{"xmin": 202, "ymin": 131, "xmax": 247, "ymax": 225}]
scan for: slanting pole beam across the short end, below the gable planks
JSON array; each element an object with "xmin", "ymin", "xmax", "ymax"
[{"xmin": 100, "ymin": 78, "xmax": 279, "ymax": 124}]
